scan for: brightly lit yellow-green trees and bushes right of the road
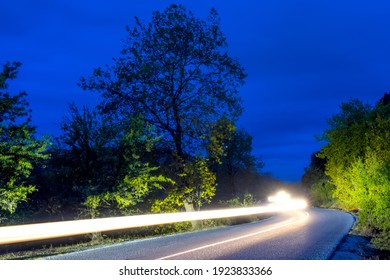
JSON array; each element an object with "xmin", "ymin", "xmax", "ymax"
[{"xmin": 302, "ymin": 93, "xmax": 390, "ymax": 249}]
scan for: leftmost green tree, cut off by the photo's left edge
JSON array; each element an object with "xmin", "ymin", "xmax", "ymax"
[{"xmin": 0, "ymin": 62, "xmax": 49, "ymax": 219}]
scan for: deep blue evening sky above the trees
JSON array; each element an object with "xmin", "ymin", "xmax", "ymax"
[{"xmin": 0, "ymin": 0, "xmax": 390, "ymax": 182}]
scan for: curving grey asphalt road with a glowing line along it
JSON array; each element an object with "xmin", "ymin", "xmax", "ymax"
[{"xmin": 48, "ymin": 208, "xmax": 354, "ymax": 260}]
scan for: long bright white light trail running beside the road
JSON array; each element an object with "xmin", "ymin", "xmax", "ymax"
[{"xmin": 0, "ymin": 194, "xmax": 307, "ymax": 244}]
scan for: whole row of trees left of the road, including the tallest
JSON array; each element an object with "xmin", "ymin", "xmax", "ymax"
[{"xmin": 0, "ymin": 5, "xmax": 288, "ymax": 230}]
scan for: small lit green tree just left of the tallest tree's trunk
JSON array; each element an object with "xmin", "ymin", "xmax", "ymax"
[{"xmin": 79, "ymin": 117, "xmax": 175, "ymax": 216}]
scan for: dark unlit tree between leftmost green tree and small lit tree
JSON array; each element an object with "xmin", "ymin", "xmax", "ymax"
[{"xmin": 29, "ymin": 103, "xmax": 121, "ymax": 219}]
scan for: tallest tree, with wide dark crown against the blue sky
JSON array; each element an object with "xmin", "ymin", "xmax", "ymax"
[{"xmin": 81, "ymin": 5, "xmax": 246, "ymax": 212}]
